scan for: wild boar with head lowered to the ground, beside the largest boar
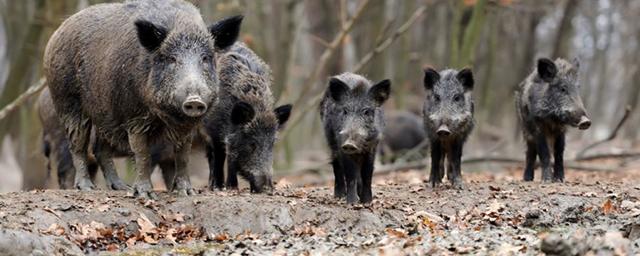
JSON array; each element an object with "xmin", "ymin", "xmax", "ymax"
[{"xmin": 205, "ymin": 17, "xmax": 292, "ymax": 193}]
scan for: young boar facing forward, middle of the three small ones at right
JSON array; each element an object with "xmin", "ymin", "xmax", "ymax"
[{"xmin": 423, "ymin": 68, "xmax": 474, "ymax": 189}]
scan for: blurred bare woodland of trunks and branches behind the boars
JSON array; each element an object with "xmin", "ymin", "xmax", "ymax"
[{"xmin": 0, "ymin": 0, "xmax": 640, "ymax": 190}]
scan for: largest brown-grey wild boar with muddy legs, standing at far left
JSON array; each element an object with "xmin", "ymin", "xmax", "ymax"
[{"xmin": 44, "ymin": 0, "xmax": 240, "ymax": 197}]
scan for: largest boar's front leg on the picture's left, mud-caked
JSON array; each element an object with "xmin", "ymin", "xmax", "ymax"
[{"xmin": 129, "ymin": 133, "xmax": 157, "ymax": 199}]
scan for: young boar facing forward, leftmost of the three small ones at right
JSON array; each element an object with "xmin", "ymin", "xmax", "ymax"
[{"xmin": 320, "ymin": 73, "xmax": 391, "ymax": 204}]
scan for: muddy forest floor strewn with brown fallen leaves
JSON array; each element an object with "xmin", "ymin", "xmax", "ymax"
[{"xmin": 0, "ymin": 169, "xmax": 640, "ymax": 255}]
